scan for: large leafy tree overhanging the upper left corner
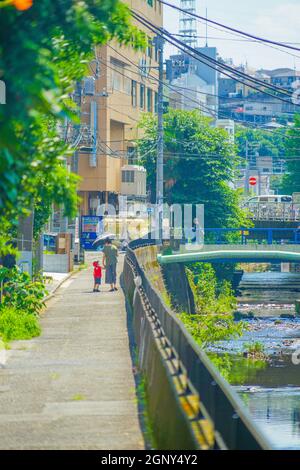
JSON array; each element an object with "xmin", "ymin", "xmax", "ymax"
[{"xmin": 0, "ymin": 0, "xmax": 146, "ymax": 252}]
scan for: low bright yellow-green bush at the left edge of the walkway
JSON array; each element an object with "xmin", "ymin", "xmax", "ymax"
[{"xmin": 0, "ymin": 306, "xmax": 41, "ymax": 341}]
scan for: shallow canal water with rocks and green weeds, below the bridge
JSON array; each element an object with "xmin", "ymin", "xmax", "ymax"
[{"xmin": 211, "ymin": 273, "xmax": 300, "ymax": 449}]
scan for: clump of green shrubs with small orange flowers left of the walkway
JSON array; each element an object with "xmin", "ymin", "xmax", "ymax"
[{"xmin": 0, "ymin": 268, "xmax": 46, "ymax": 341}]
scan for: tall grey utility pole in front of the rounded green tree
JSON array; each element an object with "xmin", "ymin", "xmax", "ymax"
[{"xmin": 155, "ymin": 36, "xmax": 164, "ymax": 244}]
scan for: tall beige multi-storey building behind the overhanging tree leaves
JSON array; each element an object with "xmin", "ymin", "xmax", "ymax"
[{"xmin": 75, "ymin": 0, "xmax": 163, "ymax": 215}]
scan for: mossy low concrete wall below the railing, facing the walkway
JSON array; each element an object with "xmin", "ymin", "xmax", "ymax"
[{"xmin": 122, "ymin": 252, "xmax": 214, "ymax": 450}]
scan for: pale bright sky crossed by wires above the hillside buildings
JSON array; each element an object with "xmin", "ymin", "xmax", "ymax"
[{"xmin": 164, "ymin": 0, "xmax": 300, "ymax": 70}]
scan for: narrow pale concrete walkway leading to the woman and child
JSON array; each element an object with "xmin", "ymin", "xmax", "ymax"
[{"xmin": 0, "ymin": 263, "xmax": 144, "ymax": 450}]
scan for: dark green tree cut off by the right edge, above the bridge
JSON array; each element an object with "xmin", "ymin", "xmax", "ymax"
[{"xmin": 282, "ymin": 114, "xmax": 300, "ymax": 194}]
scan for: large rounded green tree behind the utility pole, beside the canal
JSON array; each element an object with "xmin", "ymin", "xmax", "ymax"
[{"xmin": 139, "ymin": 110, "xmax": 248, "ymax": 228}]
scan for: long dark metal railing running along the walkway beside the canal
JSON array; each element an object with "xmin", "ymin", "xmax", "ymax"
[{"xmin": 124, "ymin": 240, "xmax": 271, "ymax": 450}]
